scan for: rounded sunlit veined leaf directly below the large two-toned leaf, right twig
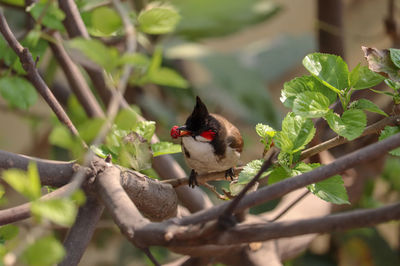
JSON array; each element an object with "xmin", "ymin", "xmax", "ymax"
[{"xmin": 293, "ymin": 91, "xmax": 330, "ymax": 118}]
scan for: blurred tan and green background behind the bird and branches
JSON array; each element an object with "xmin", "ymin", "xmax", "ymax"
[{"xmin": 0, "ymin": 0, "xmax": 400, "ymax": 266}]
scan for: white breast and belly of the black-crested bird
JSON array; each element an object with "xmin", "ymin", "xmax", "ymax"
[{"xmin": 182, "ymin": 137, "xmax": 240, "ymax": 174}]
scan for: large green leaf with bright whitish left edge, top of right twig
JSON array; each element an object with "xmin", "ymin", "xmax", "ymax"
[{"xmin": 303, "ymin": 53, "xmax": 349, "ymax": 93}]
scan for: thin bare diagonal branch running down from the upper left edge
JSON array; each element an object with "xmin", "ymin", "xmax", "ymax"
[{"xmin": 0, "ymin": 10, "xmax": 85, "ymax": 145}]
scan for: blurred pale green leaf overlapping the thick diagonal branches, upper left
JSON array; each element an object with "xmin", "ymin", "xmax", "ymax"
[{"xmin": 68, "ymin": 38, "xmax": 119, "ymax": 72}]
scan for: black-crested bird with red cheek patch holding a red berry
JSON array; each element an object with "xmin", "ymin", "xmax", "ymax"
[{"xmin": 171, "ymin": 96, "xmax": 243, "ymax": 188}]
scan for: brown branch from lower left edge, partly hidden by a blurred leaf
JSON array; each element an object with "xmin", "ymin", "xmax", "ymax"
[{"xmin": 0, "ymin": 184, "xmax": 76, "ymax": 226}]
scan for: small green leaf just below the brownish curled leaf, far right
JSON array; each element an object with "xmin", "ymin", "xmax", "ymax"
[{"xmin": 350, "ymin": 66, "xmax": 385, "ymax": 90}]
